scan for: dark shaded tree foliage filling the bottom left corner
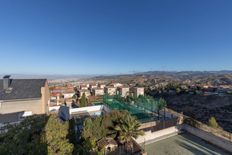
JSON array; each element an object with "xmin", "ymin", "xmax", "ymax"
[{"xmin": 0, "ymin": 115, "xmax": 48, "ymax": 155}]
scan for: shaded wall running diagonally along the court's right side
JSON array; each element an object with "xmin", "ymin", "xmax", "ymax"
[{"xmin": 182, "ymin": 124, "xmax": 232, "ymax": 153}]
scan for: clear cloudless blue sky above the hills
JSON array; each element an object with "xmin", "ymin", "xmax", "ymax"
[{"xmin": 0, "ymin": 0, "xmax": 232, "ymax": 74}]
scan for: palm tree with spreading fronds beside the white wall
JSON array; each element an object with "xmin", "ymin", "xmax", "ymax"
[{"xmin": 113, "ymin": 114, "xmax": 144, "ymax": 150}]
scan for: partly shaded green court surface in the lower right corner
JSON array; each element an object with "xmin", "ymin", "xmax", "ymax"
[{"xmin": 145, "ymin": 133, "xmax": 229, "ymax": 155}]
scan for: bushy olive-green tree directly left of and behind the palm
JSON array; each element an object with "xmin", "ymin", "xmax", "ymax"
[{"xmin": 81, "ymin": 110, "xmax": 139, "ymax": 152}]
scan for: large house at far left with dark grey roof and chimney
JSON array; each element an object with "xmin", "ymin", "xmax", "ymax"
[{"xmin": 0, "ymin": 76, "xmax": 50, "ymax": 123}]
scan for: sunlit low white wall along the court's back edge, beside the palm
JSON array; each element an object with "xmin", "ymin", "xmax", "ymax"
[{"xmin": 136, "ymin": 126, "xmax": 179, "ymax": 145}]
